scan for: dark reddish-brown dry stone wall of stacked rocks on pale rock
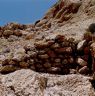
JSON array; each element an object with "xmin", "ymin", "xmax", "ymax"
[{"xmin": 0, "ymin": 33, "xmax": 95, "ymax": 74}]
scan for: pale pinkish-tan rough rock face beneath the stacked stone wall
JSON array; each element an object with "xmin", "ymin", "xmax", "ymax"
[{"xmin": 0, "ymin": 69, "xmax": 95, "ymax": 96}]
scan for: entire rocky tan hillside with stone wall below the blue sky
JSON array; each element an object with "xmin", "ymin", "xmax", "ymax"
[{"xmin": 0, "ymin": 0, "xmax": 95, "ymax": 96}]
